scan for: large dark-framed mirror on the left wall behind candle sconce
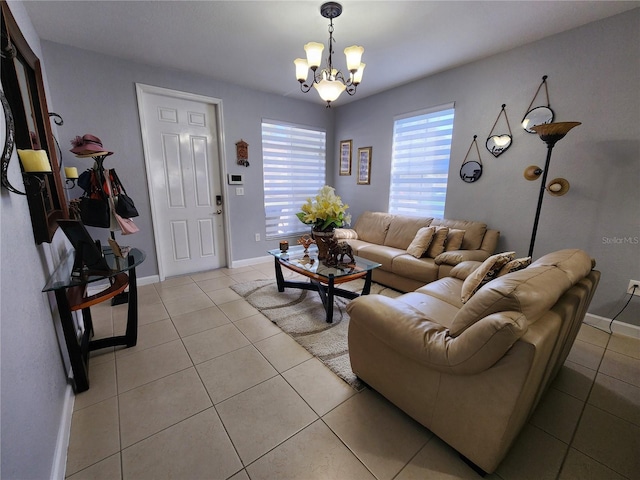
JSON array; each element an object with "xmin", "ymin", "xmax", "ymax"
[{"xmin": 0, "ymin": 1, "xmax": 68, "ymax": 244}]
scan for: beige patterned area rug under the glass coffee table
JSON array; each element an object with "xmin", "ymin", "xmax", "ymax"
[{"xmin": 231, "ymin": 280, "xmax": 402, "ymax": 390}]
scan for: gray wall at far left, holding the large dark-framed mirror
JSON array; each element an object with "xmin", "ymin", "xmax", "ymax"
[{"xmin": 0, "ymin": 2, "xmax": 72, "ymax": 479}]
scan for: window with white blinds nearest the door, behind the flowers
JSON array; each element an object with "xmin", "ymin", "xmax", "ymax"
[{"xmin": 262, "ymin": 120, "xmax": 326, "ymax": 238}]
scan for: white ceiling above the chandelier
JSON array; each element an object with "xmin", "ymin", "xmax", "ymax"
[{"xmin": 24, "ymin": 0, "xmax": 640, "ymax": 106}]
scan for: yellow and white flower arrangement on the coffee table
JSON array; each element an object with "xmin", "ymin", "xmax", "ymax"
[{"xmin": 296, "ymin": 185, "xmax": 351, "ymax": 230}]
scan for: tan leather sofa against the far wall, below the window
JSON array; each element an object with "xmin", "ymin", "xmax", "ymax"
[{"xmin": 335, "ymin": 212, "xmax": 500, "ymax": 292}]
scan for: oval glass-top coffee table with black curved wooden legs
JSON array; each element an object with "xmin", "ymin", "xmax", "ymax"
[{"xmin": 269, "ymin": 245, "xmax": 381, "ymax": 323}]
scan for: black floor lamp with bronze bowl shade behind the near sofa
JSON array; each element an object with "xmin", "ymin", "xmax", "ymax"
[{"xmin": 524, "ymin": 122, "xmax": 581, "ymax": 257}]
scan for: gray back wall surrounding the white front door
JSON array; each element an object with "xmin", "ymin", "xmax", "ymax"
[{"xmin": 42, "ymin": 41, "xmax": 333, "ymax": 277}]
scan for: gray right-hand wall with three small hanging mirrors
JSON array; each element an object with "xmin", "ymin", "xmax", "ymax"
[{"xmin": 334, "ymin": 9, "xmax": 640, "ymax": 325}]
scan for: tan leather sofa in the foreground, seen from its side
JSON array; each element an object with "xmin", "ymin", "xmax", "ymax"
[{"xmin": 347, "ymin": 250, "xmax": 600, "ymax": 472}]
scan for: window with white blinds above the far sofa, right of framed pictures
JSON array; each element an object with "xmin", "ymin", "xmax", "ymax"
[{"xmin": 389, "ymin": 104, "xmax": 454, "ymax": 218}]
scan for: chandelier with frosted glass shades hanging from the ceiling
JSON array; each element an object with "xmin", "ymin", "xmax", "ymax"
[{"xmin": 293, "ymin": 2, "xmax": 365, "ymax": 108}]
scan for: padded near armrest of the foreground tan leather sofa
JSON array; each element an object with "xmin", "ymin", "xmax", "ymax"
[{"xmin": 347, "ymin": 295, "xmax": 527, "ymax": 375}]
